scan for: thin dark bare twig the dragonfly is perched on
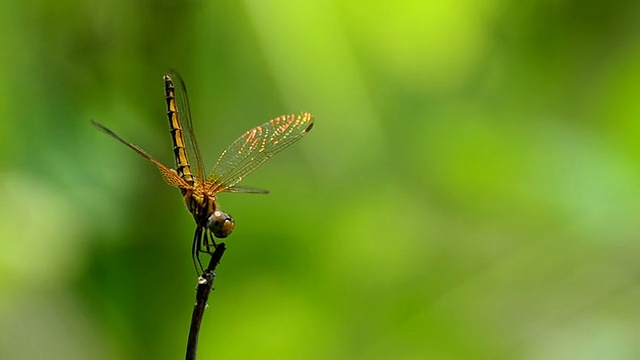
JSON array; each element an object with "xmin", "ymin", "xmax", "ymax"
[{"xmin": 187, "ymin": 243, "xmax": 226, "ymax": 360}]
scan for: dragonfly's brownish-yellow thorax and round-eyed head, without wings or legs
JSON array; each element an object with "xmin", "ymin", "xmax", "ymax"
[{"xmin": 184, "ymin": 191, "xmax": 235, "ymax": 238}]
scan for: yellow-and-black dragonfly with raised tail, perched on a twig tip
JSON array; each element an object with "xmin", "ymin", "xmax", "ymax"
[{"xmin": 91, "ymin": 70, "xmax": 314, "ymax": 270}]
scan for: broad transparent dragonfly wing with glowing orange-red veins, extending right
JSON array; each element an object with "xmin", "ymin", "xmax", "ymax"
[{"xmin": 207, "ymin": 112, "xmax": 313, "ymax": 193}]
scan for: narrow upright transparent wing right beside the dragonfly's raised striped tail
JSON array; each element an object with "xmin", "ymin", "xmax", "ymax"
[{"xmin": 166, "ymin": 69, "xmax": 204, "ymax": 181}]
